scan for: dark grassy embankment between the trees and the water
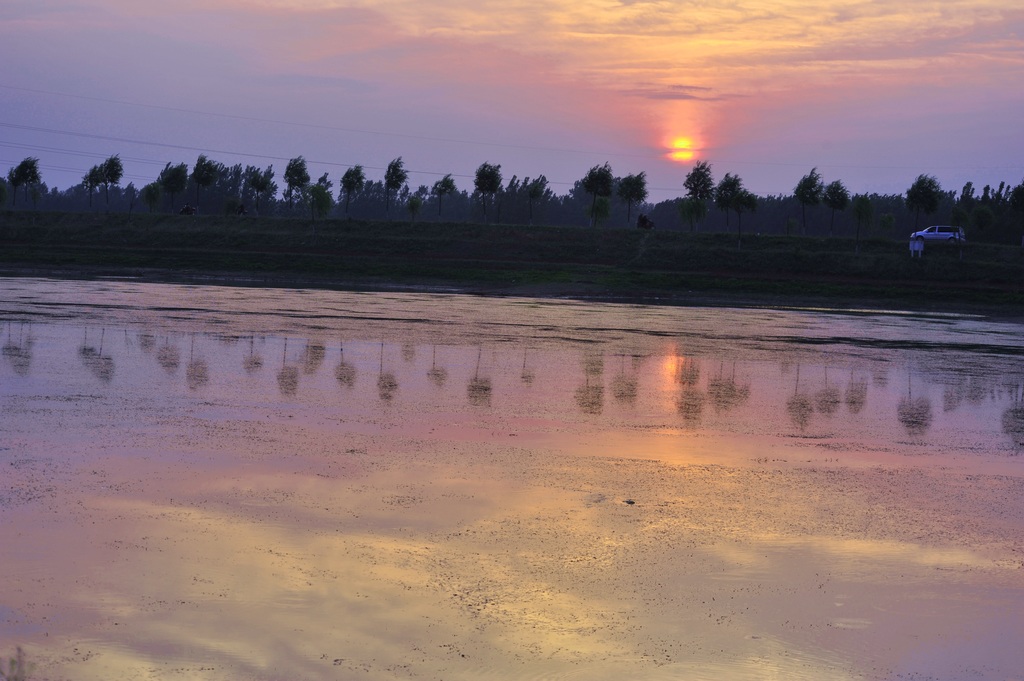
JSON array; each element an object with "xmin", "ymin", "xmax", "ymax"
[{"xmin": 0, "ymin": 211, "xmax": 1024, "ymax": 305}]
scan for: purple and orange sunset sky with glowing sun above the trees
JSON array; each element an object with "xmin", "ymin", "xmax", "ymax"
[{"xmin": 0, "ymin": 0, "xmax": 1024, "ymax": 201}]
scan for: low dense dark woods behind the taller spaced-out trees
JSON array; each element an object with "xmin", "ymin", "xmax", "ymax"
[{"xmin": 6, "ymin": 151, "xmax": 1024, "ymax": 244}]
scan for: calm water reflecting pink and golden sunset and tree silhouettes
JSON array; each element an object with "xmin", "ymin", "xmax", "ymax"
[{"xmin": 0, "ymin": 279, "xmax": 1024, "ymax": 680}]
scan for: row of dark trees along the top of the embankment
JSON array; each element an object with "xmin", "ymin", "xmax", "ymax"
[{"xmin": 6, "ymin": 155, "xmax": 1024, "ymax": 244}]
